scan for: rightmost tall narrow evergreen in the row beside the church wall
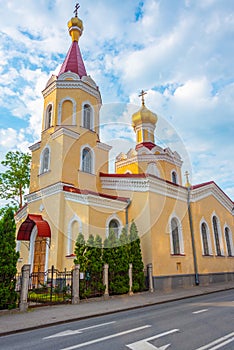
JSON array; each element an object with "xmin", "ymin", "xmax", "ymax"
[{"xmin": 129, "ymin": 221, "xmax": 145, "ymax": 292}]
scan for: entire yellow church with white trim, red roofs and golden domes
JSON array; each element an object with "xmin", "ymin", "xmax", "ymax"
[{"xmin": 16, "ymin": 8, "xmax": 234, "ymax": 289}]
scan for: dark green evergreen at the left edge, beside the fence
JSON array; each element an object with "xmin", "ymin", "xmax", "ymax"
[{"xmin": 0, "ymin": 207, "xmax": 19, "ymax": 309}]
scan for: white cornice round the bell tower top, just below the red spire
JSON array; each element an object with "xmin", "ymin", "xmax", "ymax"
[{"xmin": 42, "ymin": 80, "xmax": 101, "ymax": 104}]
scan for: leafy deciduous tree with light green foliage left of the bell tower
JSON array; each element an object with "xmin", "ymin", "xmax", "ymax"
[{"xmin": 0, "ymin": 151, "xmax": 31, "ymax": 208}]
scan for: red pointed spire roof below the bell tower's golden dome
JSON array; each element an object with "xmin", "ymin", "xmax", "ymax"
[{"xmin": 58, "ymin": 41, "xmax": 87, "ymax": 78}]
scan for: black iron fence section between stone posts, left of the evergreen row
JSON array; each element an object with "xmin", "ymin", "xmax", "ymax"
[{"xmin": 28, "ymin": 266, "xmax": 72, "ymax": 306}]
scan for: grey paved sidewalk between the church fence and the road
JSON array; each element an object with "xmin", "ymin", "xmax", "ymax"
[{"xmin": 0, "ymin": 282, "xmax": 234, "ymax": 336}]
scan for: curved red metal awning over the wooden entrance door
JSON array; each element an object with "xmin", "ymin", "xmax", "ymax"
[{"xmin": 17, "ymin": 214, "xmax": 51, "ymax": 241}]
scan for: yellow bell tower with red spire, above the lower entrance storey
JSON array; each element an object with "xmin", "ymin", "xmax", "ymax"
[{"xmin": 30, "ymin": 4, "xmax": 110, "ymax": 192}]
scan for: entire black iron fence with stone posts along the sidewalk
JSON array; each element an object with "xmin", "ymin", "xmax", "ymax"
[{"xmin": 15, "ymin": 266, "xmax": 149, "ymax": 307}]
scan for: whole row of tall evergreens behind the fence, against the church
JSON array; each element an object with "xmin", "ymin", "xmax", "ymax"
[{"xmin": 74, "ymin": 222, "xmax": 144, "ymax": 298}]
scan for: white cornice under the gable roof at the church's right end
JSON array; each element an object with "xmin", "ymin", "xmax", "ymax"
[{"xmin": 190, "ymin": 183, "xmax": 234, "ymax": 214}]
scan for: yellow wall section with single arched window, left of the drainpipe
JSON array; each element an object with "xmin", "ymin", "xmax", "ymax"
[{"xmin": 151, "ymin": 194, "xmax": 193, "ymax": 276}]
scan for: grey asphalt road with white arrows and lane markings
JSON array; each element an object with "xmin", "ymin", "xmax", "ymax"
[{"xmin": 0, "ymin": 290, "xmax": 234, "ymax": 350}]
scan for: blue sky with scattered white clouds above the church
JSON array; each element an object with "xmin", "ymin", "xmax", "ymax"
[{"xmin": 0, "ymin": 0, "xmax": 234, "ymax": 199}]
